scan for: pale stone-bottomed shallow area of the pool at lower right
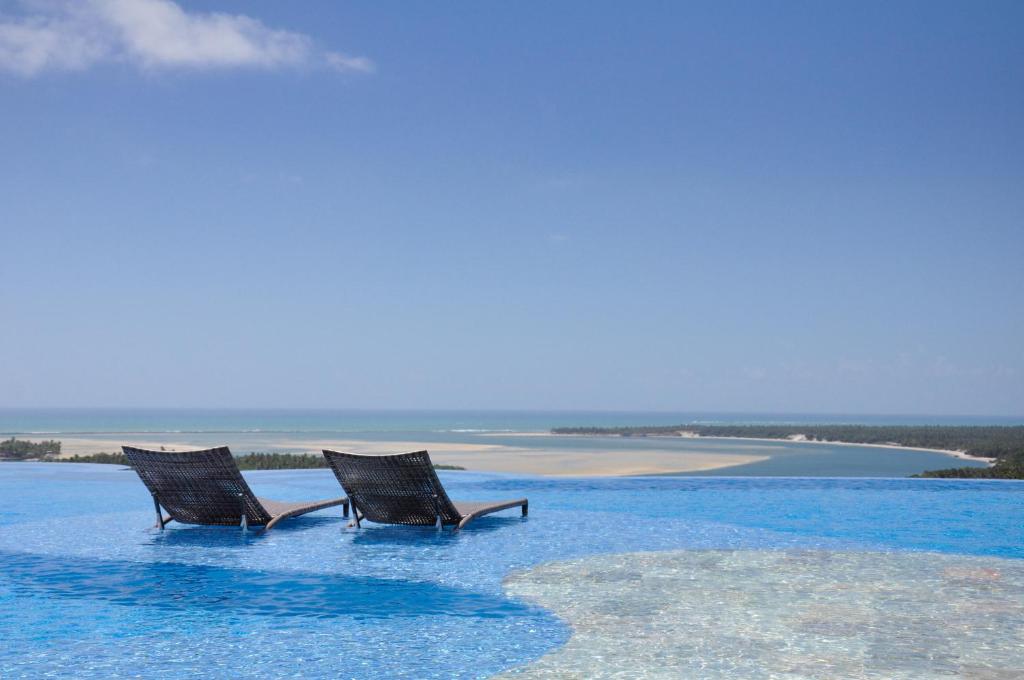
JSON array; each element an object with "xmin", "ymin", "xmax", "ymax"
[{"xmin": 506, "ymin": 550, "xmax": 1024, "ymax": 680}]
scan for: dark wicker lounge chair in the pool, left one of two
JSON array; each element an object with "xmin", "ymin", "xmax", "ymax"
[{"xmin": 121, "ymin": 447, "xmax": 348, "ymax": 530}]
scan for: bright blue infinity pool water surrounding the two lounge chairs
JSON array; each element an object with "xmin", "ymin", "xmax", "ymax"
[{"xmin": 0, "ymin": 463, "xmax": 1024, "ymax": 678}]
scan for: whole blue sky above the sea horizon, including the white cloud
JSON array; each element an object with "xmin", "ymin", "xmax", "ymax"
[{"xmin": 0, "ymin": 0, "xmax": 1024, "ymax": 416}]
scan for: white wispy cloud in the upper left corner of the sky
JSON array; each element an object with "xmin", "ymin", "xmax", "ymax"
[{"xmin": 0, "ymin": 0, "xmax": 374, "ymax": 77}]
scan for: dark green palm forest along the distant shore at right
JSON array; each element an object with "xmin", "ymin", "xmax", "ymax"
[{"xmin": 551, "ymin": 425, "xmax": 1024, "ymax": 479}]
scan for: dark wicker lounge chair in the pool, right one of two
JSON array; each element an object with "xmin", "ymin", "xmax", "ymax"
[{"xmin": 324, "ymin": 451, "xmax": 529, "ymax": 530}]
